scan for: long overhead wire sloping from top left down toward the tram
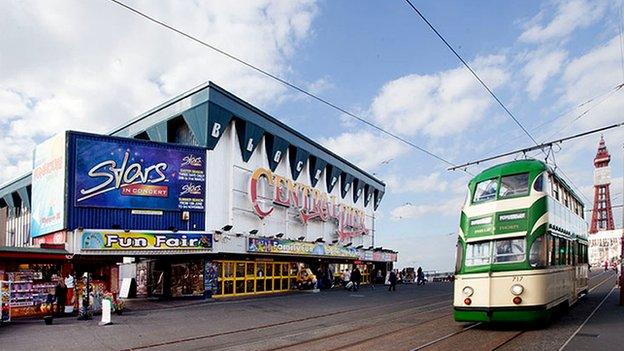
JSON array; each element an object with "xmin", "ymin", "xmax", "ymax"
[{"xmin": 109, "ymin": 0, "xmax": 472, "ymax": 174}]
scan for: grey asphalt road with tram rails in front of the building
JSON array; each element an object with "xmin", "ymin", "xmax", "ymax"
[{"xmin": 0, "ymin": 272, "xmax": 621, "ymax": 351}]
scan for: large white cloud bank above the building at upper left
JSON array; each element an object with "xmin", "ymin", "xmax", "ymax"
[{"xmin": 0, "ymin": 0, "xmax": 317, "ymax": 181}]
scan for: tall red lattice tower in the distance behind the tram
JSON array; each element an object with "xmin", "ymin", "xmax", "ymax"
[{"xmin": 589, "ymin": 136, "xmax": 615, "ymax": 234}]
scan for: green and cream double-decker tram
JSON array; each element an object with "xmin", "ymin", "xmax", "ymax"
[{"xmin": 453, "ymin": 160, "xmax": 589, "ymax": 322}]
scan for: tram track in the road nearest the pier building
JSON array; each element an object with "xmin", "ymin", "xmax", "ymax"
[{"xmin": 123, "ymin": 293, "xmax": 452, "ymax": 351}]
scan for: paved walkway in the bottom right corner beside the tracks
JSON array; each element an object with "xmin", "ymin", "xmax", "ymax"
[{"xmin": 564, "ymin": 287, "xmax": 624, "ymax": 350}]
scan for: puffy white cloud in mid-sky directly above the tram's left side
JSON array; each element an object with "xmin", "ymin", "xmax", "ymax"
[{"xmin": 371, "ymin": 55, "xmax": 509, "ymax": 137}]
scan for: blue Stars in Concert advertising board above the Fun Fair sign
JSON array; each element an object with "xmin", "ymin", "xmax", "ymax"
[{"xmin": 72, "ymin": 135, "xmax": 206, "ymax": 211}]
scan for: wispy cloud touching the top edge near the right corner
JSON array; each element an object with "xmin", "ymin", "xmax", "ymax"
[{"xmin": 520, "ymin": 0, "xmax": 609, "ymax": 43}]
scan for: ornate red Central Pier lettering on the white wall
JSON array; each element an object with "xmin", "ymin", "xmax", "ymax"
[{"xmin": 249, "ymin": 168, "xmax": 369, "ymax": 240}]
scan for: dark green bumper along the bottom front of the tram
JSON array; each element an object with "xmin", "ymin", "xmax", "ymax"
[{"xmin": 453, "ymin": 306, "xmax": 551, "ymax": 322}]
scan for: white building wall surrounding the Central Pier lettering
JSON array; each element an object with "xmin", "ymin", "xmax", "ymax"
[{"xmin": 206, "ymin": 122, "xmax": 374, "ymax": 252}]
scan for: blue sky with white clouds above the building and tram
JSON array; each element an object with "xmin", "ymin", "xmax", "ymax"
[{"xmin": 0, "ymin": 0, "xmax": 624, "ymax": 271}]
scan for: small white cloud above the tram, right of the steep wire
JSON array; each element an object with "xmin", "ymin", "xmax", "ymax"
[{"xmin": 522, "ymin": 49, "xmax": 567, "ymax": 100}]
